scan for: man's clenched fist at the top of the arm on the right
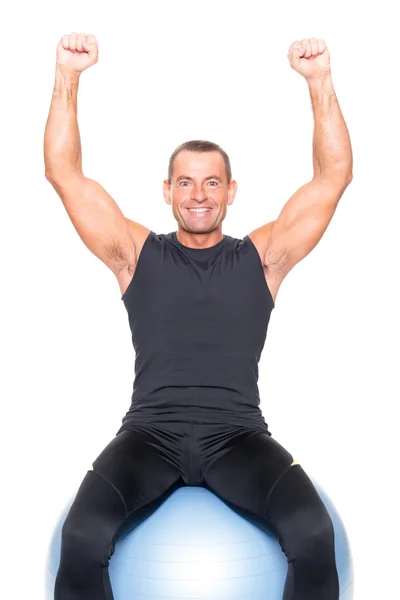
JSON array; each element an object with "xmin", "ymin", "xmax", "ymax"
[{"xmin": 288, "ymin": 38, "xmax": 331, "ymax": 80}]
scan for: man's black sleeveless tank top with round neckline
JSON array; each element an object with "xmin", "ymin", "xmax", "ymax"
[{"xmin": 118, "ymin": 231, "xmax": 274, "ymax": 433}]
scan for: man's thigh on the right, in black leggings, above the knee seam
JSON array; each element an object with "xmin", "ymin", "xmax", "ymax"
[{"xmin": 204, "ymin": 429, "xmax": 296, "ymax": 517}]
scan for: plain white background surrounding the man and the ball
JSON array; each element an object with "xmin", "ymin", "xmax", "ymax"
[{"xmin": 0, "ymin": 0, "xmax": 400, "ymax": 600}]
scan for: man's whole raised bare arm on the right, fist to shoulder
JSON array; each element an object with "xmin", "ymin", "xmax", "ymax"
[{"xmin": 250, "ymin": 38, "xmax": 353, "ymax": 295}]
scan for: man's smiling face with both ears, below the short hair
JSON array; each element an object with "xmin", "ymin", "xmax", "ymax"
[{"xmin": 164, "ymin": 150, "xmax": 237, "ymax": 233}]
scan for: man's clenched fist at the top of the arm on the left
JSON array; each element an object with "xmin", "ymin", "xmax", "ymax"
[{"xmin": 57, "ymin": 33, "xmax": 99, "ymax": 75}]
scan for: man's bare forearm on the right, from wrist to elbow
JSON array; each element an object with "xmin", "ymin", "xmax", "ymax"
[{"xmin": 308, "ymin": 75, "xmax": 353, "ymax": 178}]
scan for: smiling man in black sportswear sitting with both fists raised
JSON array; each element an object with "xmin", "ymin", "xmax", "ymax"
[{"xmin": 45, "ymin": 33, "xmax": 352, "ymax": 600}]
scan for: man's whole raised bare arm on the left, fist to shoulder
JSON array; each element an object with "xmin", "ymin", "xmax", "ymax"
[{"xmin": 44, "ymin": 33, "xmax": 149, "ymax": 284}]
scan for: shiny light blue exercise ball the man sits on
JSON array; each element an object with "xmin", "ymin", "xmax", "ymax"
[{"xmin": 46, "ymin": 482, "xmax": 353, "ymax": 600}]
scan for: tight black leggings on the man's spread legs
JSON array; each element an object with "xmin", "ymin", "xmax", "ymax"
[{"xmin": 54, "ymin": 422, "xmax": 339, "ymax": 600}]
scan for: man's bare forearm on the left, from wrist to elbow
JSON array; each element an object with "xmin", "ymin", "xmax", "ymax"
[{"xmin": 44, "ymin": 67, "xmax": 82, "ymax": 178}]
